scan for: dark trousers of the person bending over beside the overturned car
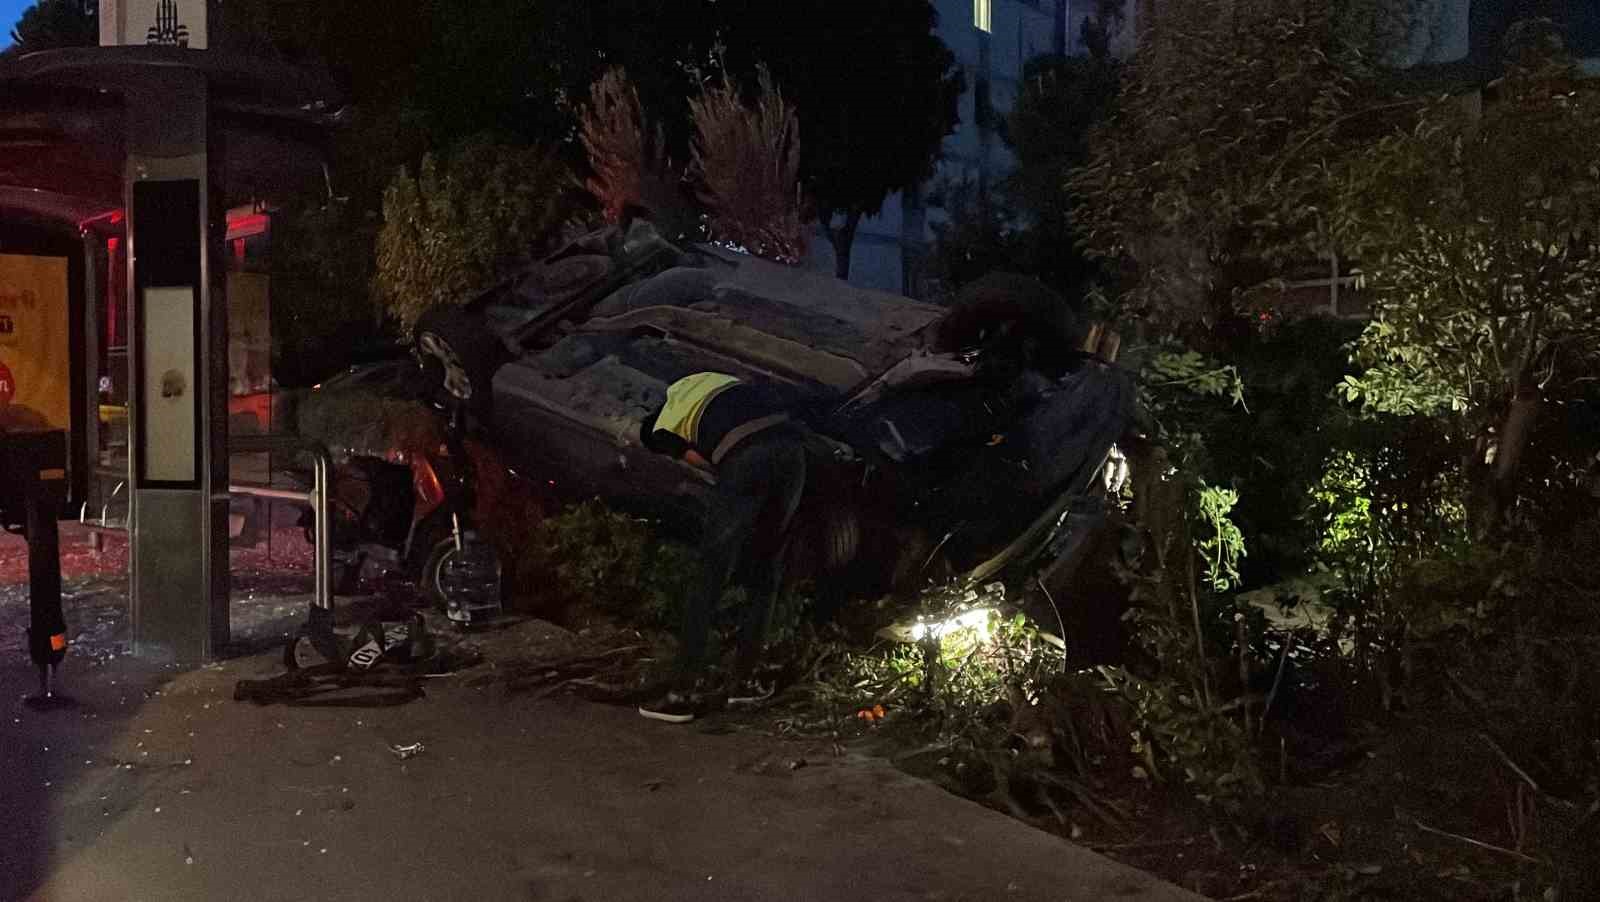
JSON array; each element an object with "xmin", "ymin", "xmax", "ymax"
[{"xmin": 677, "ymin": 429, "xmax": 806, "ymax": 688}]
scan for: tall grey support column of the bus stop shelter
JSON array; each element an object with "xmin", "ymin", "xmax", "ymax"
[{"xmin": 125, "ymin": 69, "xmax": 229, "ymax": 664}]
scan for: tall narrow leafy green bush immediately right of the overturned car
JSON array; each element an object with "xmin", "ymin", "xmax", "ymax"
[{"xmin": 1102, "ymin": 342, "xmax": 1262, "ymax": 804}]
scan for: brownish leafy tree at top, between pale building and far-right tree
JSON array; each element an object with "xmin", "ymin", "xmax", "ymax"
[{"xmin": 1067, "ymin": 0, "xmax": 1387, "ymax": 326}]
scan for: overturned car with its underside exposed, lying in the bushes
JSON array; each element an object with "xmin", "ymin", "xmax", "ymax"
[{"xmin": 414, "ymin": 221, "xmax": 1134, "ymax": 610}]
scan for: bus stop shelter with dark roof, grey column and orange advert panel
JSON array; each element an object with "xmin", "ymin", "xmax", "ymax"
[{"xmin": 0, "ymin": 43, "xmax": 338, "ymax": 662}]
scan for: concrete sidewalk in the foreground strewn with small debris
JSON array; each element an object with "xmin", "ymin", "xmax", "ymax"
[{"xmin": 0, "ymin": 636, "xmax": 1197, "ymax": 902}]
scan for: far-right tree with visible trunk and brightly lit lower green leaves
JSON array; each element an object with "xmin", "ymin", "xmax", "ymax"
[{"xmin": 1341, "ymin": 30, "xmax": 1600, "ymax": 533}]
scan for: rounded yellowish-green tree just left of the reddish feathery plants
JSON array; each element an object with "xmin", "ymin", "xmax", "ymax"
[{"xmin": 373, "ymin": 141, "xmax": 578, "ymax": 333}]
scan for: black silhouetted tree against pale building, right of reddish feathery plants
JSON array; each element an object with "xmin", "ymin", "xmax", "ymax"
[{"xmin": 718, "ymin": 0, "xmax": 965, "ymax": 278}]
